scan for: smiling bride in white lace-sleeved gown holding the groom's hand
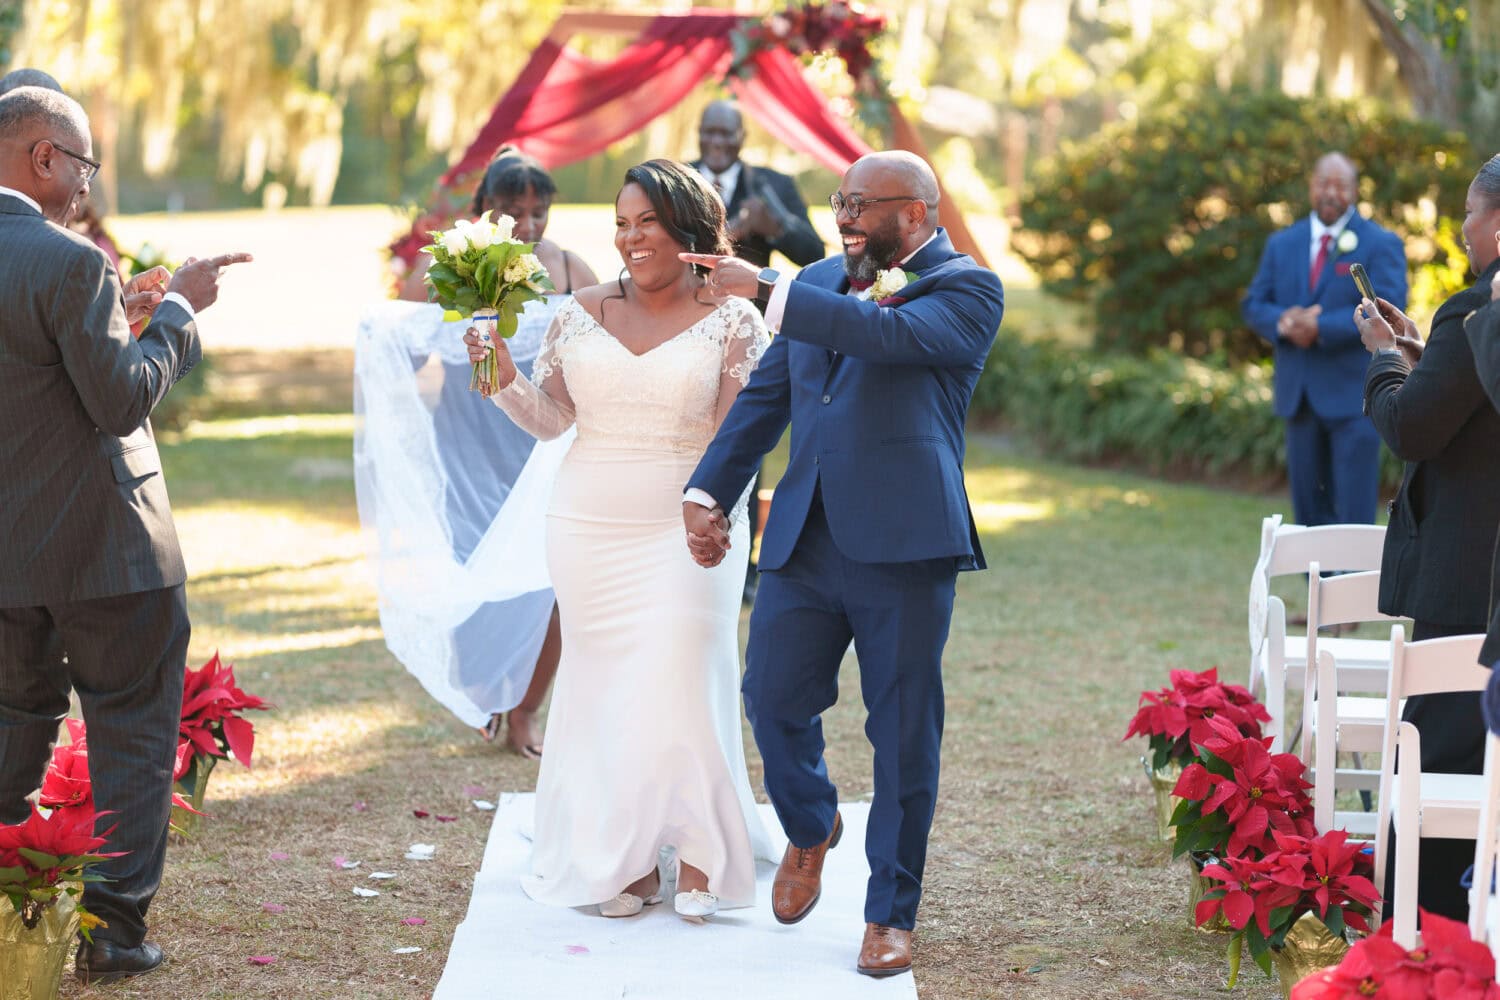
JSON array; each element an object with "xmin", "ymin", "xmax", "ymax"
[{"xmin": 464, "ymin": 159, "xmax": 773, "ymax": 919}]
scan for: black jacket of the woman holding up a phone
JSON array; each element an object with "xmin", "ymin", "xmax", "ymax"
[{"xmin": 1365, "ymin": 261, "xmax": 1500, "ymax": 633}]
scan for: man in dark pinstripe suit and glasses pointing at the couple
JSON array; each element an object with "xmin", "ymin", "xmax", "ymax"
[{"xmin": 0, "ymin": 87, "xmax": 249, "ymax": 982}]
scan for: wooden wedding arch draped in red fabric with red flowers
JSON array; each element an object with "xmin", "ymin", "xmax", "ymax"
[{"xmin": 392, "ymin": 0, "xmax": 984, "ymax": 264}]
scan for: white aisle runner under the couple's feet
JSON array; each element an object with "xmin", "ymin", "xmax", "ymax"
[{"xmin": 434, "ymin": 795, "xmax": 917, "ymax": 1000}]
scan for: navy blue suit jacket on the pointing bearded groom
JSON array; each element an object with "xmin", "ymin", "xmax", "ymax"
[{"xmin": 689, "ymin": 229, "xmax": 1005, "ymax": 570}]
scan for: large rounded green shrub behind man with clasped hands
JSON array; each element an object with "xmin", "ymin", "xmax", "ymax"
[{"xmin": 1013, "ymin": 90, "xmax": 1478, "ymax": 360}]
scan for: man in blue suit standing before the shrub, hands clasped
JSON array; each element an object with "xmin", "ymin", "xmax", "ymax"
[{"xmin": 1242, "ymin": 153, "xmax": 1407, "ymax": 525}]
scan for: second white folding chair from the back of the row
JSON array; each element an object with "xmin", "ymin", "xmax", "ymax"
[{"xmin": 1299, "ymin": 562, "xmax": 1398, "ymax": 840}]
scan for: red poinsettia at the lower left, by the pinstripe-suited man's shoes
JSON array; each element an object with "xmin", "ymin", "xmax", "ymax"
[{"xmin": 0, "ymin": 807, "xmax": 123, "ymax": 937}]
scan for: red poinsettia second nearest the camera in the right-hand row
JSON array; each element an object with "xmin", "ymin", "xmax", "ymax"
[{"xmin": 1193, "ymin": 831, "xmax": 1380, "ymax": 987}]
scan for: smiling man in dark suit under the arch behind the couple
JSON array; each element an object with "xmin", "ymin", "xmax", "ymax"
[{"xmin": 692, "ymin": 100, "xmax": 824, "ymax": 604}]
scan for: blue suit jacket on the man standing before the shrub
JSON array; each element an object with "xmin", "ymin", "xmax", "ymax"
[{"xmin": 1242, "ymin": 211, "xmax": 1407, "ymax": 420}]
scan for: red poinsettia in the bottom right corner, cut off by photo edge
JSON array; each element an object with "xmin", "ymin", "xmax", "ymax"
[{"xmin": 1292, "ymin": 910, "xmax": 1500, "ymax": 1000}]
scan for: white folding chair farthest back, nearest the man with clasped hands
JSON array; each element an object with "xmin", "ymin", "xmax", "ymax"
[{"xmin": 1248, "ymin": 514, "xmax": 1389, "ymax": 753}]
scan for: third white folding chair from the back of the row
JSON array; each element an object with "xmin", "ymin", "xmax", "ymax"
[{"xmin": 1376, "ymin": 625, "xmax": 1490, "ymax": 949}]
